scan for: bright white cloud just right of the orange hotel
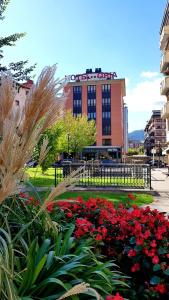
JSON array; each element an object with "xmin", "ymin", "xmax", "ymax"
[{"xmin": 125, "ymin": 72, "xmax": 166, "ymax": 114}]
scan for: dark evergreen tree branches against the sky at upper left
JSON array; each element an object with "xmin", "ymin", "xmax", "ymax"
[{"xmin": 0, "ymin": 0, "xmax": 36, "ymax": 81}]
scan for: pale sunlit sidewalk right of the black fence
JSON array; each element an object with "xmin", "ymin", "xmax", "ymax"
[{"xmin": 149, "ymin": 168, "xmax": 169, "ymax": 214}]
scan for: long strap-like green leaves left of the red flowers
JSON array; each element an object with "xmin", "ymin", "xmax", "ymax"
[{"xmin": 0, "ymin": 193, "xmax": 128, "ymax": 300}]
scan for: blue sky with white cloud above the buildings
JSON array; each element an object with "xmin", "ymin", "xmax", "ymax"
[{"xmin": 1, "ymin": 0, "xmax": 166, "ymax": 131}]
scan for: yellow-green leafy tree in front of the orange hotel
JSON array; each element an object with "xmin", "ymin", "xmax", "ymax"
[{"xmin": 58, "ymin": 112, "xmax": 96, "ymax": 156}]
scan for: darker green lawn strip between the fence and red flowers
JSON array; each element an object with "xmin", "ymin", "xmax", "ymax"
[{"xmin": 30, "ymin": 191, "xmax": 153, "ymax": 206}]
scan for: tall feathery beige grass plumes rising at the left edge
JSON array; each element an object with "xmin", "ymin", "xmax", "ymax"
[{"xmin": 0, "ymin": 66, "xmax": 65, "ymax": 203}]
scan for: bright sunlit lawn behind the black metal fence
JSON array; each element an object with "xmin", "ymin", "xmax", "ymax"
[{"xmin": 26, "ymin": 167, "xmax": 144, "ymax": 187}]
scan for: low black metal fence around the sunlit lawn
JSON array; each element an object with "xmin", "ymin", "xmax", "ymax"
[{"xmin": 55, "ymin": 163, "xmax": 151, "ymax": 189}]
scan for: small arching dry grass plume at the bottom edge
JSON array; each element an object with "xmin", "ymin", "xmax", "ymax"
[{"xmin": 58, "ymin": 282, "xmax": 100, "ymax": 300}]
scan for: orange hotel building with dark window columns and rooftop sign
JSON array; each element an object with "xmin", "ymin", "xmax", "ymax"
[{"xmin": 65, "ymin": 68, "xmax": 128, "ymax": 159}]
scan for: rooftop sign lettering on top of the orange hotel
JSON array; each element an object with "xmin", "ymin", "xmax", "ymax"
[{"xmin": 65, "ymin": 72, "xmax": 117, "ymax": 81}]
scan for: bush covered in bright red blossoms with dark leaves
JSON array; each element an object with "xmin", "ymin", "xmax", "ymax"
[{"xmin": 58, "ymin": 197, "xmax": 169, "ymax": 299}]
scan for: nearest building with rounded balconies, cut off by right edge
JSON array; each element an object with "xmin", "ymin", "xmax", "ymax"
[{"xmin": 160, "ymin": 0, "xmax": 169, "ymax": 159}]
